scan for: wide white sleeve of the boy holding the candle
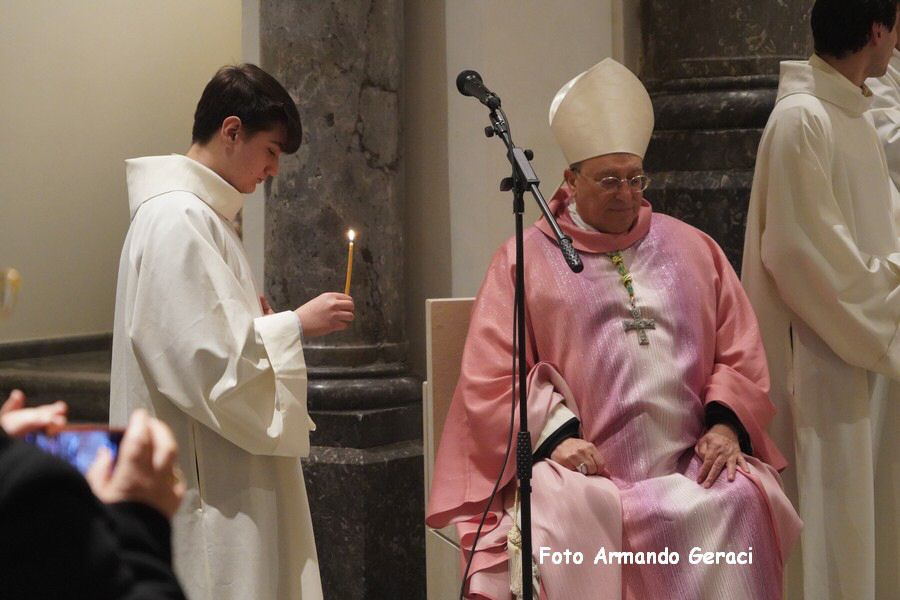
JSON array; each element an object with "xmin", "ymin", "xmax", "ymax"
[{"xmin": 126, "ymin": 204, "xmax": 314, "ymax": 456}]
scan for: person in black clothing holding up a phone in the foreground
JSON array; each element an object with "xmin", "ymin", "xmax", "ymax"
[{"xmin": 0, "ymin": 392, "xmax": 185, "ymax": 600}]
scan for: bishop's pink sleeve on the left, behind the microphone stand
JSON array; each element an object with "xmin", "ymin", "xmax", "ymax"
[{"xmin": 426, "ymin": 244, "xmax": 574, "ymax": 528}]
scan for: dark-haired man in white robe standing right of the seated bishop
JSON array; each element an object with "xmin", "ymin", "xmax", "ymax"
[{"xmin": 742, "ymin": 0, "xmax": 900, "ymax": 600}]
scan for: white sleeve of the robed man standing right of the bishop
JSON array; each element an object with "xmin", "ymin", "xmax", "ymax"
[{"xmin": 762, "ymin": 110, "xmax": 900, "ymax": 379}]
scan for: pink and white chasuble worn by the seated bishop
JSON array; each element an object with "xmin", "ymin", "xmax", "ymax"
[{"xmin": 427, "ymin": 186, "xmax": 801, "ymax": 600}]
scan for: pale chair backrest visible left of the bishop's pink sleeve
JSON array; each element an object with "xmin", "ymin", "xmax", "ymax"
[{"xmin": 423, "ymin": 298, "xmax": 475, "ymax": 503}]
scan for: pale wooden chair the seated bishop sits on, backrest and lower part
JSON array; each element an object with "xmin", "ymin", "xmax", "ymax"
[{"xmin": 422, "ymin": 298, "xmax": 474, "ymax": 600}]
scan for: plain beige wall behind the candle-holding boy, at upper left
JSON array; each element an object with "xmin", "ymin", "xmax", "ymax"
[{"xmin": 0, "ymin": 0, "xmax": 241, "ymax": 341}]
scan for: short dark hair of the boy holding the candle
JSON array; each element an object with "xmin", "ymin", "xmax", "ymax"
[{"xmin": 191, "ymin": 63, "xmax": 303, "ymax": 154}]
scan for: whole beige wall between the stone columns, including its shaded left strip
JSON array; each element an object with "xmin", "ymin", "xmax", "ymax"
[{"xmin": 403, "ymin": 0, "xmax": 629, "ymax": 374}]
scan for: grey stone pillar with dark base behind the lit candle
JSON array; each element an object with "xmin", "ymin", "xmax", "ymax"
[{"xmin": 260, "ymin": 0, "xmax": 425, "ymax": 600}]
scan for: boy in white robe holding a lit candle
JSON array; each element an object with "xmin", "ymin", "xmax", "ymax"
[{"xmin": 110, "ymin": 65, "xmax": 353, "ymax": 600}]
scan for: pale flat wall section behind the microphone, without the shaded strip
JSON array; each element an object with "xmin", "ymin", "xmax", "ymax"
[{"xmin": 446, "ymin": 0, "xmax": 612, "ymax": 296}]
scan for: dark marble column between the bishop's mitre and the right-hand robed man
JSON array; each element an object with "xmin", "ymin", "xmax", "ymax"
[{"xmin": 641, "ymin": 0, "xmax": 813, "ymax": 269}]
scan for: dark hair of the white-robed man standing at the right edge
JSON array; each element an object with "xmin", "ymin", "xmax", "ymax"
[{"xmin": 811, "ymin": 0, "xmax": 898, "ymax": 58}]
